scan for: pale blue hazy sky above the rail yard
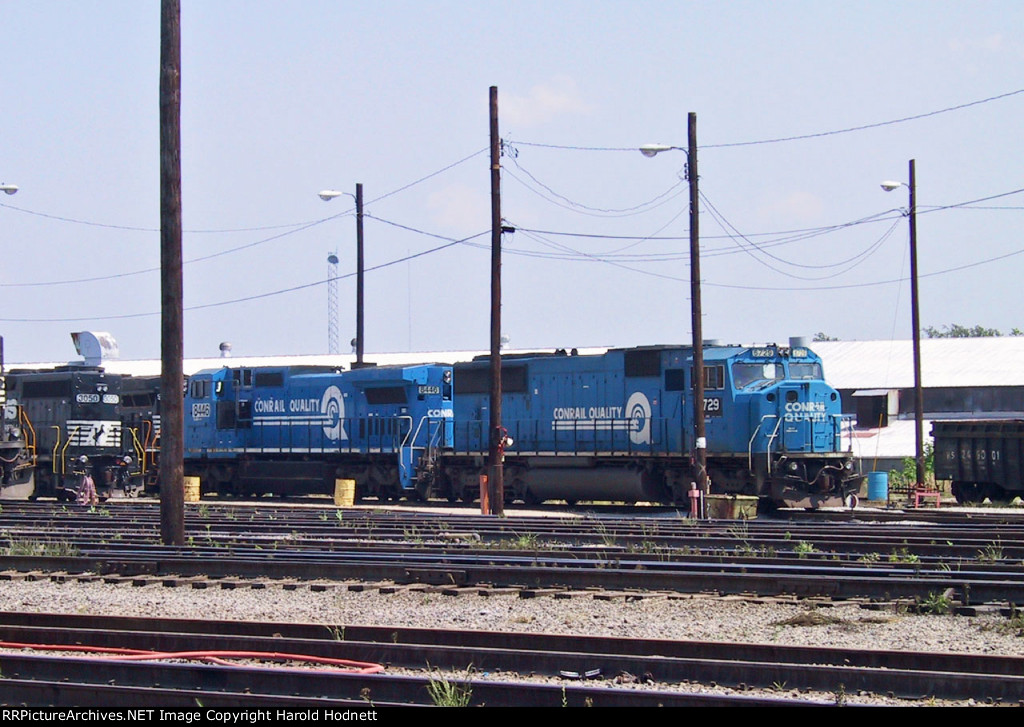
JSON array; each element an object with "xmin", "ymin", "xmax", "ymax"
[{"xmin": 0, "ymin": 0, "xmax": 1024, "ymax": 362}]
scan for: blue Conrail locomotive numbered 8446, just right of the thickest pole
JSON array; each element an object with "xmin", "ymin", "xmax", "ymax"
[{"xmin": 184, "ymin": 365, "xmax": 453, "ymax": 500}]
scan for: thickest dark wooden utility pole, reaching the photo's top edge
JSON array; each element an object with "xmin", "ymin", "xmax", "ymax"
[{"xmin": 160, "ymin": 0, "xmax": 185, "ymax": 546}]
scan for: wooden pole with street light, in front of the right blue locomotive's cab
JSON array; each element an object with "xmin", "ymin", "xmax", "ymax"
[{"xmin": 640, "ymin": 112, "xmax": 709, "ymax": 517}]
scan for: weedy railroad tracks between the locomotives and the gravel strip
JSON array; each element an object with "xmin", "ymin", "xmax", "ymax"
[{"xmin": 6, "ymin": 503, "xmax": 1024, "ymax": 605}]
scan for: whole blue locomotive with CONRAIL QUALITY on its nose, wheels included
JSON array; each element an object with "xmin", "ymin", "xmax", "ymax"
[{"xmin": 438, "ymin": 345, "xmax": 862, "ymax": 507}]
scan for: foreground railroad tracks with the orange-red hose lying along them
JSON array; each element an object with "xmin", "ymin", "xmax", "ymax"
[{"xmin": 6, "ymin": 613, "xmax": 1024, "ymax": 708}]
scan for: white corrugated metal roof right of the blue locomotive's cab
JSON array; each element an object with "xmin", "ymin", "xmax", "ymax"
[{"xmin": 811, "ymin": 336, "xmax": 1024, "ymax": 389}]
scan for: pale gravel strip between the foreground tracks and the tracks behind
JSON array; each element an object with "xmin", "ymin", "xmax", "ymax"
[{"xmin": 0, "ymin": 580, "xmax": 1024, "ymax": 703}]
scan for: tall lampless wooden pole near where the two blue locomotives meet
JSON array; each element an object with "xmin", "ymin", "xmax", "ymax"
[{"xmin": 481, "ymin": 86, "xmax": 505, "ymax": 515}]
